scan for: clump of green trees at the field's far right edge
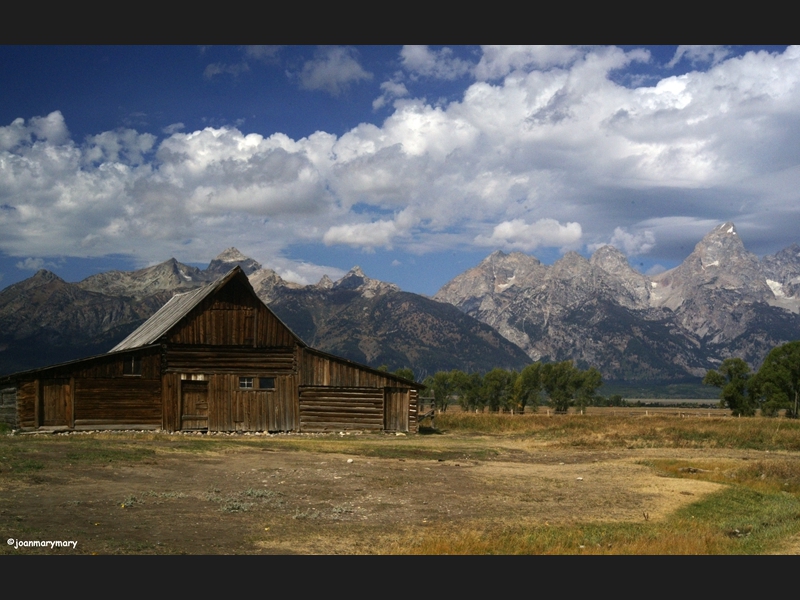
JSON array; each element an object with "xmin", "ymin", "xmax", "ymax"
[{"xmin": 703, "ymin": 341, "xmax": 800, "ymax": 419}]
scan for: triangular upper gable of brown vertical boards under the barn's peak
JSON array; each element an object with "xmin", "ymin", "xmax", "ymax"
[{"xmin": 169, "ymin": 279, "xmax": 297, "ymax": 348}]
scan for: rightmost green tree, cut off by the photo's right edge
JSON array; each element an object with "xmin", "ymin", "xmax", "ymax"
[{"xmin": 751, "ymin": 341, "xmax": 800, "ymax": 419}]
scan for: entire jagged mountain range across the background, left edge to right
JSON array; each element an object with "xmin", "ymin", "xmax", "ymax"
[{"xmin": 0, "ymin": 223, "xmax": 800, "ymax": 382}]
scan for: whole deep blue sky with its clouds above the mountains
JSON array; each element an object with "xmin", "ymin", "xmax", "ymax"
[{"xmin": 0, "ymin": 46, "xmax": 800, "ymax": 295}]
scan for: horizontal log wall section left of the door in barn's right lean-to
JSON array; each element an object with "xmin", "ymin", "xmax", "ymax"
[{"xmin": 300, "ymin": 387, "xmax": 384, "ymax": 432}]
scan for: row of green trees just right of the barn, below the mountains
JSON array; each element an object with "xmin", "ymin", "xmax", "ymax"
[{"xmin": 395, "ymin": 360, "xmax": 608, "ymax": 414}]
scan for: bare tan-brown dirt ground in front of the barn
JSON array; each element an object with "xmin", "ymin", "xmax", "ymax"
[{"xmin": 7, "ymin": 428, "xmax": 788, "ymax": 554}]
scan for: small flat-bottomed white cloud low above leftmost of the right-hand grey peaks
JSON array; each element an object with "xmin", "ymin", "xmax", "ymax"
[{"xmin": 475, "ymin": 219, "xmax": 582, "ymax": 252}]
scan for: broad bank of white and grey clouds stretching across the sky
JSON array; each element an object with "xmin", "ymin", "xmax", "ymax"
[{"xmin": 0, "ymin": 48, "xmax": 800, "ymax": 276}]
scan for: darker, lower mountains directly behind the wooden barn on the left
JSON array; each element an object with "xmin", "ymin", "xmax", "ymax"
[{"xmin": 0, "ymin": 248, "xmax": 530, "ymax": 378}]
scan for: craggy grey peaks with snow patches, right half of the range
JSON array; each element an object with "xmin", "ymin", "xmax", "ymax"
[{"xmin": 434, "ymin": 223, "xmax": 800, "ymax": 381}]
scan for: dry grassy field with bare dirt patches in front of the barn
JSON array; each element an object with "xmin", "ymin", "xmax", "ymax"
[{"xmin": 0, "ymin": 408, "xmax": 800, "ymax": 554}]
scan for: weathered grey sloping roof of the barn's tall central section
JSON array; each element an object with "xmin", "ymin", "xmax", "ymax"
[{"xmin": 109, "ymin": 266, "xmax": 305, "ymax": 352}]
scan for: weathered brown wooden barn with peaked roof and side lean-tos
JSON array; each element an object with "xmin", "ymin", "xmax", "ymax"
[{"xmin": 0, "ymin": 267, "xmax": 423, "ymax": 433}]
